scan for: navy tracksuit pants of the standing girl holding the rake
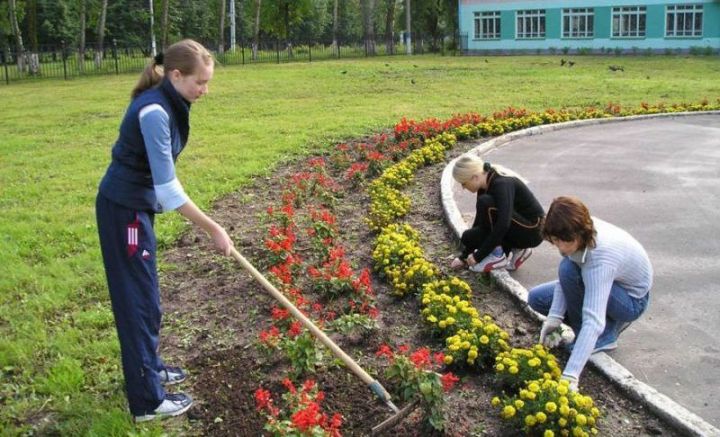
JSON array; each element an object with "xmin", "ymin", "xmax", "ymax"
[{"xmin": 95, "ymin": 194, "xmax": 165, "ymax": 416}]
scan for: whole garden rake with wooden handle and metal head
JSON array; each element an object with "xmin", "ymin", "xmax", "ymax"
[{"xmin": 231, "ymin": 247, "xmax": 418, "ymax": 434}]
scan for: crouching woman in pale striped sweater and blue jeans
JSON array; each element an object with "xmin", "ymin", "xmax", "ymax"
[{"xmin": 528, "ymin": 197, "xmax": 653, "ymax": 390}]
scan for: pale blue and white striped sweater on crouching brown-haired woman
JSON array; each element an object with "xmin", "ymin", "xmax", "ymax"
[{"xmin": 548, "ymin": 217, "xmax": 653, "ymax": 378}]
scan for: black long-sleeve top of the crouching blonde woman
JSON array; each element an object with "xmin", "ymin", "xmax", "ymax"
[{"xmin": 473, "ymin": 169, "xmax": 545, "ymax": 262}]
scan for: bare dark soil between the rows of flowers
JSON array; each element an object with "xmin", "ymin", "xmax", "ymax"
[{"xmin": 161, "ymin": 144, "xmax": 678, "ymax": 436}]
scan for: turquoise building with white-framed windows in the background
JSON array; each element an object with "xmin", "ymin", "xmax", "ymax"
[{"xmin": 458, "ymin": 0, "xmax": 720, "ymax": 54}]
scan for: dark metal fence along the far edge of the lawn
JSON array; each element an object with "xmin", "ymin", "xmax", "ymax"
[{"xmin": 0, "ymin": 35, "xmax": 463, "ymax": 85}]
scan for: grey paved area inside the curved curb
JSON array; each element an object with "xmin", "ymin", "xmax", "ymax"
[{"xmin": 453, "ymin": 114, "xmax": 720, "ymax": 427}]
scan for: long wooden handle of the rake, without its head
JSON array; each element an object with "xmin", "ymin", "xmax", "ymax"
[{"xmin": 230, "ymin": 247, "xmax": 392, "ymax": 405}]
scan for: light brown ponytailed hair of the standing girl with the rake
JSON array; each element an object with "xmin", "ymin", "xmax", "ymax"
[{"xmin": 131, "ymin": 39, "xmax": 215, "ymax": 99}]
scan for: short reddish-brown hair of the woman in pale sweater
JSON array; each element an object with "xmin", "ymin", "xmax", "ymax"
[{"xmin": 542, "ymin": 196, "xmax": 597, "ymax": 250}]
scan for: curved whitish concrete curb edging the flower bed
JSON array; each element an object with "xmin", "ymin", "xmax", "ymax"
[{"xmin": 440, "ymin": 111, "xmax": 720, "ymax": 437}]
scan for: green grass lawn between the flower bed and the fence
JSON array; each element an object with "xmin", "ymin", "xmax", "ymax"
[{"xmin": 0, "ymin": 56, "xmax": 720, "ymax": 435}]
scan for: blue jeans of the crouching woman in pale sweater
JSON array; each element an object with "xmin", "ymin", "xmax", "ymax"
[{"xmin": 528, "ymin": 258, "xmax": 650, "ymax": 345}]
